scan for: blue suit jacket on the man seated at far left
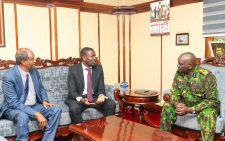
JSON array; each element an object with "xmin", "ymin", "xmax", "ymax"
[{"xmin": 0, "ymin": 65, "xmax": 48, "ymax": 117}]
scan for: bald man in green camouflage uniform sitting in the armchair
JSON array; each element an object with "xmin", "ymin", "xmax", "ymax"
[{"xmin": 160, "ymin": 52, "xmax": 220, "ymax": 141}]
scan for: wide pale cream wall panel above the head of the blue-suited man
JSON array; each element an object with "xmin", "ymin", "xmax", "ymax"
[{"xmin": 17, "ymin": 5, "xmax": 50, "ymax": 59}]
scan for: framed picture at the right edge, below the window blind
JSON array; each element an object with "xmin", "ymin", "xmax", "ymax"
[{"xmin": 209, "ymin": 41, "xmax": 225, "ymax": 58}]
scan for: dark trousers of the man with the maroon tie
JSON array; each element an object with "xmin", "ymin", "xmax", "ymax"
[{"xmin": 67, "ymin": 99, "xmax": 116, "ymax": 124}]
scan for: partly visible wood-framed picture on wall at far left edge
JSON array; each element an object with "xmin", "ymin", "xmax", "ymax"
[{"xmin": 0, "ymin": 0, "xmax": 5, "ymax": 47}]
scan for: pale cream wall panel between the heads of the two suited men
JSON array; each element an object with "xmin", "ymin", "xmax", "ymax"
[{"xmin": 57, "ymin": 7, "xmax": 79, "ymax": 58}]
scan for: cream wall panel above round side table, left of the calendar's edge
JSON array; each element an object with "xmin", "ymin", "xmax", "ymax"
[{"xmin": 131, "ymin": 12, "xmax": 161, "ymax": 91}]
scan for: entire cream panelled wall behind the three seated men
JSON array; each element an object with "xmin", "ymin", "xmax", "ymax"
[{"xmin": 0, "ymin": 1, "xmax": 205, "ymax": 94}]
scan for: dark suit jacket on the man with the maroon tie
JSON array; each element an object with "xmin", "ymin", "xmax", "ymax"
[{"xmin": 65, "ymin": 63, "xmax": 105, "ymax": 103}]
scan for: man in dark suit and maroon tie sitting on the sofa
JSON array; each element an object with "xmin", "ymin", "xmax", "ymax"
[{"xmin": 65, "ymin": 47, "xmax": 116, "ymax": 123}]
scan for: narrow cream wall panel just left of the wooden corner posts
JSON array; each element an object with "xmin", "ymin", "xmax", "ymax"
[{"xmin": 100, "ymin": 14, "xmax": 118, "ymax": 84}]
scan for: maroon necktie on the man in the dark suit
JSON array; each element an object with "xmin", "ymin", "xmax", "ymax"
[{"xmin": 87, "ymin": 67, "xmax": 93, "ymax": 102}]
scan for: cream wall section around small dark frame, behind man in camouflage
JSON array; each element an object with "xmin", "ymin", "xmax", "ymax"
[{"xmin": 163, "ymin": 2, "xmax": 205, "ymax": 89}]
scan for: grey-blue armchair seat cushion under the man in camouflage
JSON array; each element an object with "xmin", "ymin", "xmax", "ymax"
[{"xmin": 175, "ymin": 114, "xmax": 224, "ymax": 134}]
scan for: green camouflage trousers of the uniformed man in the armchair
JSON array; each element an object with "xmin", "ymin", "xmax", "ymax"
[{"xmin": 160, "ymin": 103, "xmax": 218, "ymax": 141}]
